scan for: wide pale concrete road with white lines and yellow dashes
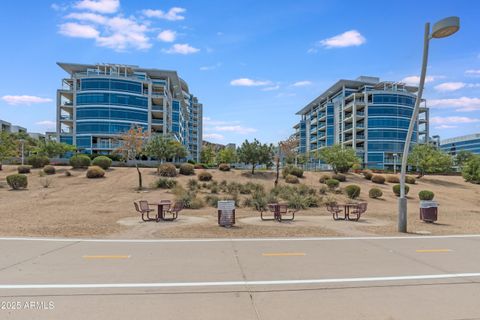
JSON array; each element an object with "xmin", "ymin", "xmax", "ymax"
[{"xmin": 0, "ymin": 236, "xmax": 480, "ymax": 320}]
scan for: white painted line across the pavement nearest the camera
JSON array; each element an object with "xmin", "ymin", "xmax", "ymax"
[{"xmin": 0, "ymin": 272, "xmax": 480, "ymax": 290}]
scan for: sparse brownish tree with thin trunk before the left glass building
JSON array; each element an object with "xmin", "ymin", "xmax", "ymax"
[{"xmin": 114, "ymin": 126, "xmax": 148, "ymax": 190}]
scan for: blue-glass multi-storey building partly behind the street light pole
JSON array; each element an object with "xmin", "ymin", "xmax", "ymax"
[{"xmin": 294, "ymin": 76, "xmax": 429, "ymax": 170}]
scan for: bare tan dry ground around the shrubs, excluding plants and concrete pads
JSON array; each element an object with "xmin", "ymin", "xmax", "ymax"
[{"xmin": 0, "ymin": 166, "xmax": 480, "ymax": 238}]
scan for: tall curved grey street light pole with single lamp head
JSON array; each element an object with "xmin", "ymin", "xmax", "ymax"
[{"xmin": 398, "ymin": 17, "xmax": 460, "ymax": 232}]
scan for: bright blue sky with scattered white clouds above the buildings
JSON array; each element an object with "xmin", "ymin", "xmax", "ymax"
[{"xmin": 0, "ymin": 0, "xmax": 480, "ymax": 144}]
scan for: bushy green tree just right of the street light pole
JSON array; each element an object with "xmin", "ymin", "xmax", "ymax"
[{"xmin": 408, "ymin": 144, "xmax": 453, "ymax": 178}]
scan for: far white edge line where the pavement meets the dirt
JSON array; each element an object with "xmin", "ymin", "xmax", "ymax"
[{"xmin": 0, "ymin": 234, "xmax": 480, "ymax": 243}]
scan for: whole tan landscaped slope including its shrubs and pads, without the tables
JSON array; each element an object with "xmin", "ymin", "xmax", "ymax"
[{"xmin": 0, "ymin": 166, "xmax": 480, "ymax": 238}]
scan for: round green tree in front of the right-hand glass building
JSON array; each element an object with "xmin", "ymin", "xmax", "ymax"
[{"xmin": 318, "ymin": 144, "xmax": 360, "ymax": 173}]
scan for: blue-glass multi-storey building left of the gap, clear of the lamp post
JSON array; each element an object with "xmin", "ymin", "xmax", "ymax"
[{"xmin": 57, "ymin": 63, "xmax": 203, "ymax": 161}]
